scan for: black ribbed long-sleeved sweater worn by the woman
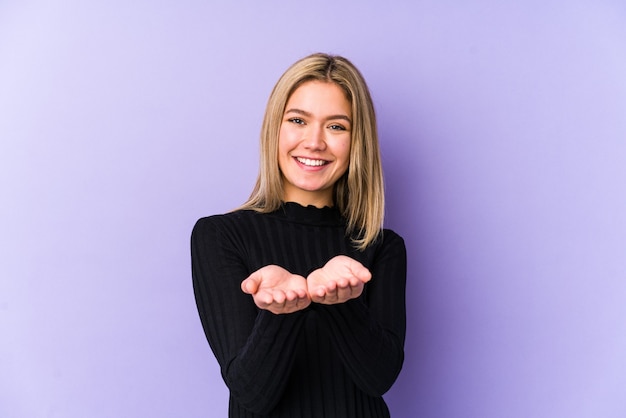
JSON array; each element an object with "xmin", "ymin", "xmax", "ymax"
[{"xmin": 191, "ymin": 203, "xmax": 406, "ymax": 418}]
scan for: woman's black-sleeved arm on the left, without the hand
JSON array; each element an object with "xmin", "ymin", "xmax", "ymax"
[{"xmin": 191, "ymin": 218, "xmax": 302, "ymax": 414}]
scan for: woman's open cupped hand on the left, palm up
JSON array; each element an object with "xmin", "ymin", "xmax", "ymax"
[{"xmin": 241, "ymin": 265, "xmax": 311, "ymax": 314}]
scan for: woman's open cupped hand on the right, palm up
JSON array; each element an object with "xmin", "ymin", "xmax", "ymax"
[{"xmin": 307, "ymin": 255, "xmax": 372, "ymax": 305}]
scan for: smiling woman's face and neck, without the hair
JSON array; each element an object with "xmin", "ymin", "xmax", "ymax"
[{"xmin": 278, "ymin": 81, "xmax": 352, "ymax": 207}]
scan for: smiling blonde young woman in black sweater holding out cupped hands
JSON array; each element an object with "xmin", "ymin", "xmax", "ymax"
[{"xmin": 191, "ymin": 54, "xmax": 406, "ymax": 418}]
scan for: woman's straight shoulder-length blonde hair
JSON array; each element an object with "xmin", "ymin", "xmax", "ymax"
[{"xmin": 239, "ymin": 53, "xmax": 385, "ymax": 250}]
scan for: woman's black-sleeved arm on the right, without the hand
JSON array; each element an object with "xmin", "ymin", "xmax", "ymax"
[{"xmin": 315, "ymin": 231, "xmax": 406, "ymax": 396}]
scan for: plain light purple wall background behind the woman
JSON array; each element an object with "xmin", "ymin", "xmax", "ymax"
[{"xmin": 0, "ymin": 0, "xmax": 626, "ymax": 418}]
